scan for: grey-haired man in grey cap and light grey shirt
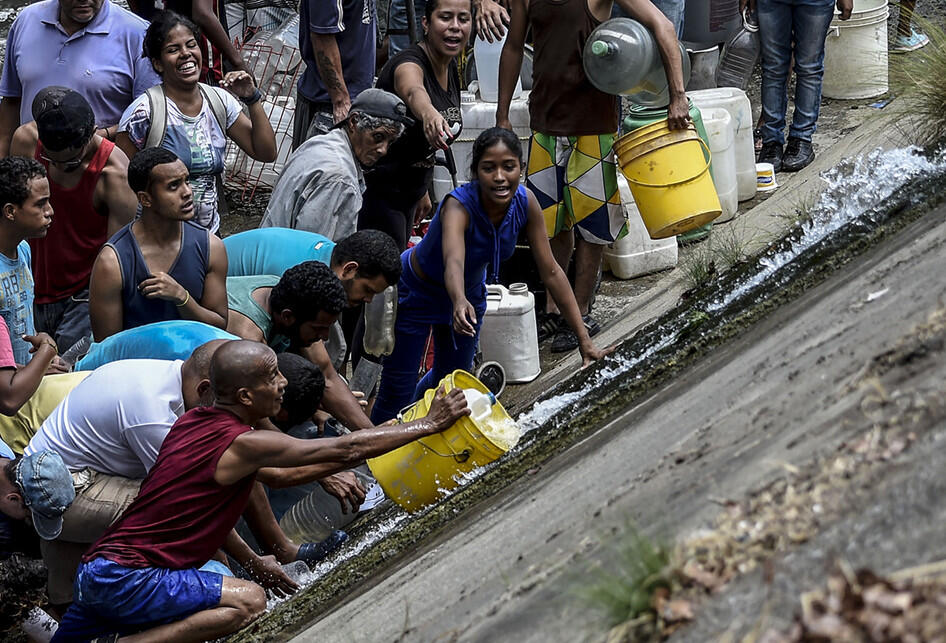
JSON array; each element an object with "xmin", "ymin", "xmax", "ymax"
[{"xmin": 260, "ymin": 89, "xmax": 411, "ymax": 242}]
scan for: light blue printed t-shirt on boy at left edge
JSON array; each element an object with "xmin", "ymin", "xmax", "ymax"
[{"xmin": 0, "ymin": 241, "xmax": 36, "ymax": 364}]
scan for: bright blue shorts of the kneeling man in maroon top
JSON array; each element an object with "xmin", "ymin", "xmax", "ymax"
[{"xmin": 53, "ymin": 558, "xmax": 223, "ymax": 641}]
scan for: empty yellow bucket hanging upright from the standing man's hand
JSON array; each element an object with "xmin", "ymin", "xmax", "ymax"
[{"xmin": 614, "ymin": 119, "xmax": 723, "ymax": 239}]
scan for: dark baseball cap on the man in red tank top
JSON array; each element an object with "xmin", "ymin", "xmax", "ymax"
[{"xmin": 32, "ymin": 85, "xmax": 95, "ymax": 152}]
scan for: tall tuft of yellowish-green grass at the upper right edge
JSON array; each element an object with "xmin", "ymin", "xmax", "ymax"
[{"xmin": 890, "ymin": 14, "xmax": 946, "ymax": 144}]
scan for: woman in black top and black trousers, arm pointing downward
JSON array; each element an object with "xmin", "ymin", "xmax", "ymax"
[{"xmin": 358, "ymin": 0, "xmax": 473, "ymax": 250}]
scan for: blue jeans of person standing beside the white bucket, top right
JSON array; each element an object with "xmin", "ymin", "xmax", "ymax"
[{"xmin": 756, "ymin": 0, "xmax": 834, "ymax": 143}]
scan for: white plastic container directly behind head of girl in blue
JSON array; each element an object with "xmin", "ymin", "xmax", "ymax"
[{"xmin": 434, "ymin": 92, "xmax": 532, "ymax": 201}]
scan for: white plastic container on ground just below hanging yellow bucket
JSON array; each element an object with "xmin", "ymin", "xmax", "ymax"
[{"xmin": 604, "ymin": 174, "xmax": 677, "ymax": 279}]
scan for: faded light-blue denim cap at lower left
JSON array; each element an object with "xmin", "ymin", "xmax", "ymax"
[{"xmin": 16, "ymin": 449, "xmax": 76, "ymax": 540}]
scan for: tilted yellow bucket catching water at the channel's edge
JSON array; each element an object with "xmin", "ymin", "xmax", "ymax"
[{"xmin": 368, "ymin": 370, "xmax": 510, "ymax": 511}]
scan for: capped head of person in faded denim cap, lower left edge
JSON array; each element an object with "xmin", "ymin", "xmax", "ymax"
[{"xmin": 0, "ymin": 442, "xmax": 76, "ymax": 540}]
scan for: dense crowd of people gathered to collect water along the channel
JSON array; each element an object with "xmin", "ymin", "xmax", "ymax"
[{"xmin": 0, "ymin": 0, "xmax": 920, "ymax": 641}]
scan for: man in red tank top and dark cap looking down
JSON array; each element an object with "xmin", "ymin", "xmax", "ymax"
[{"xmin": 10, "ymin": 86, "xmax": 138, "ymax": 351}]
